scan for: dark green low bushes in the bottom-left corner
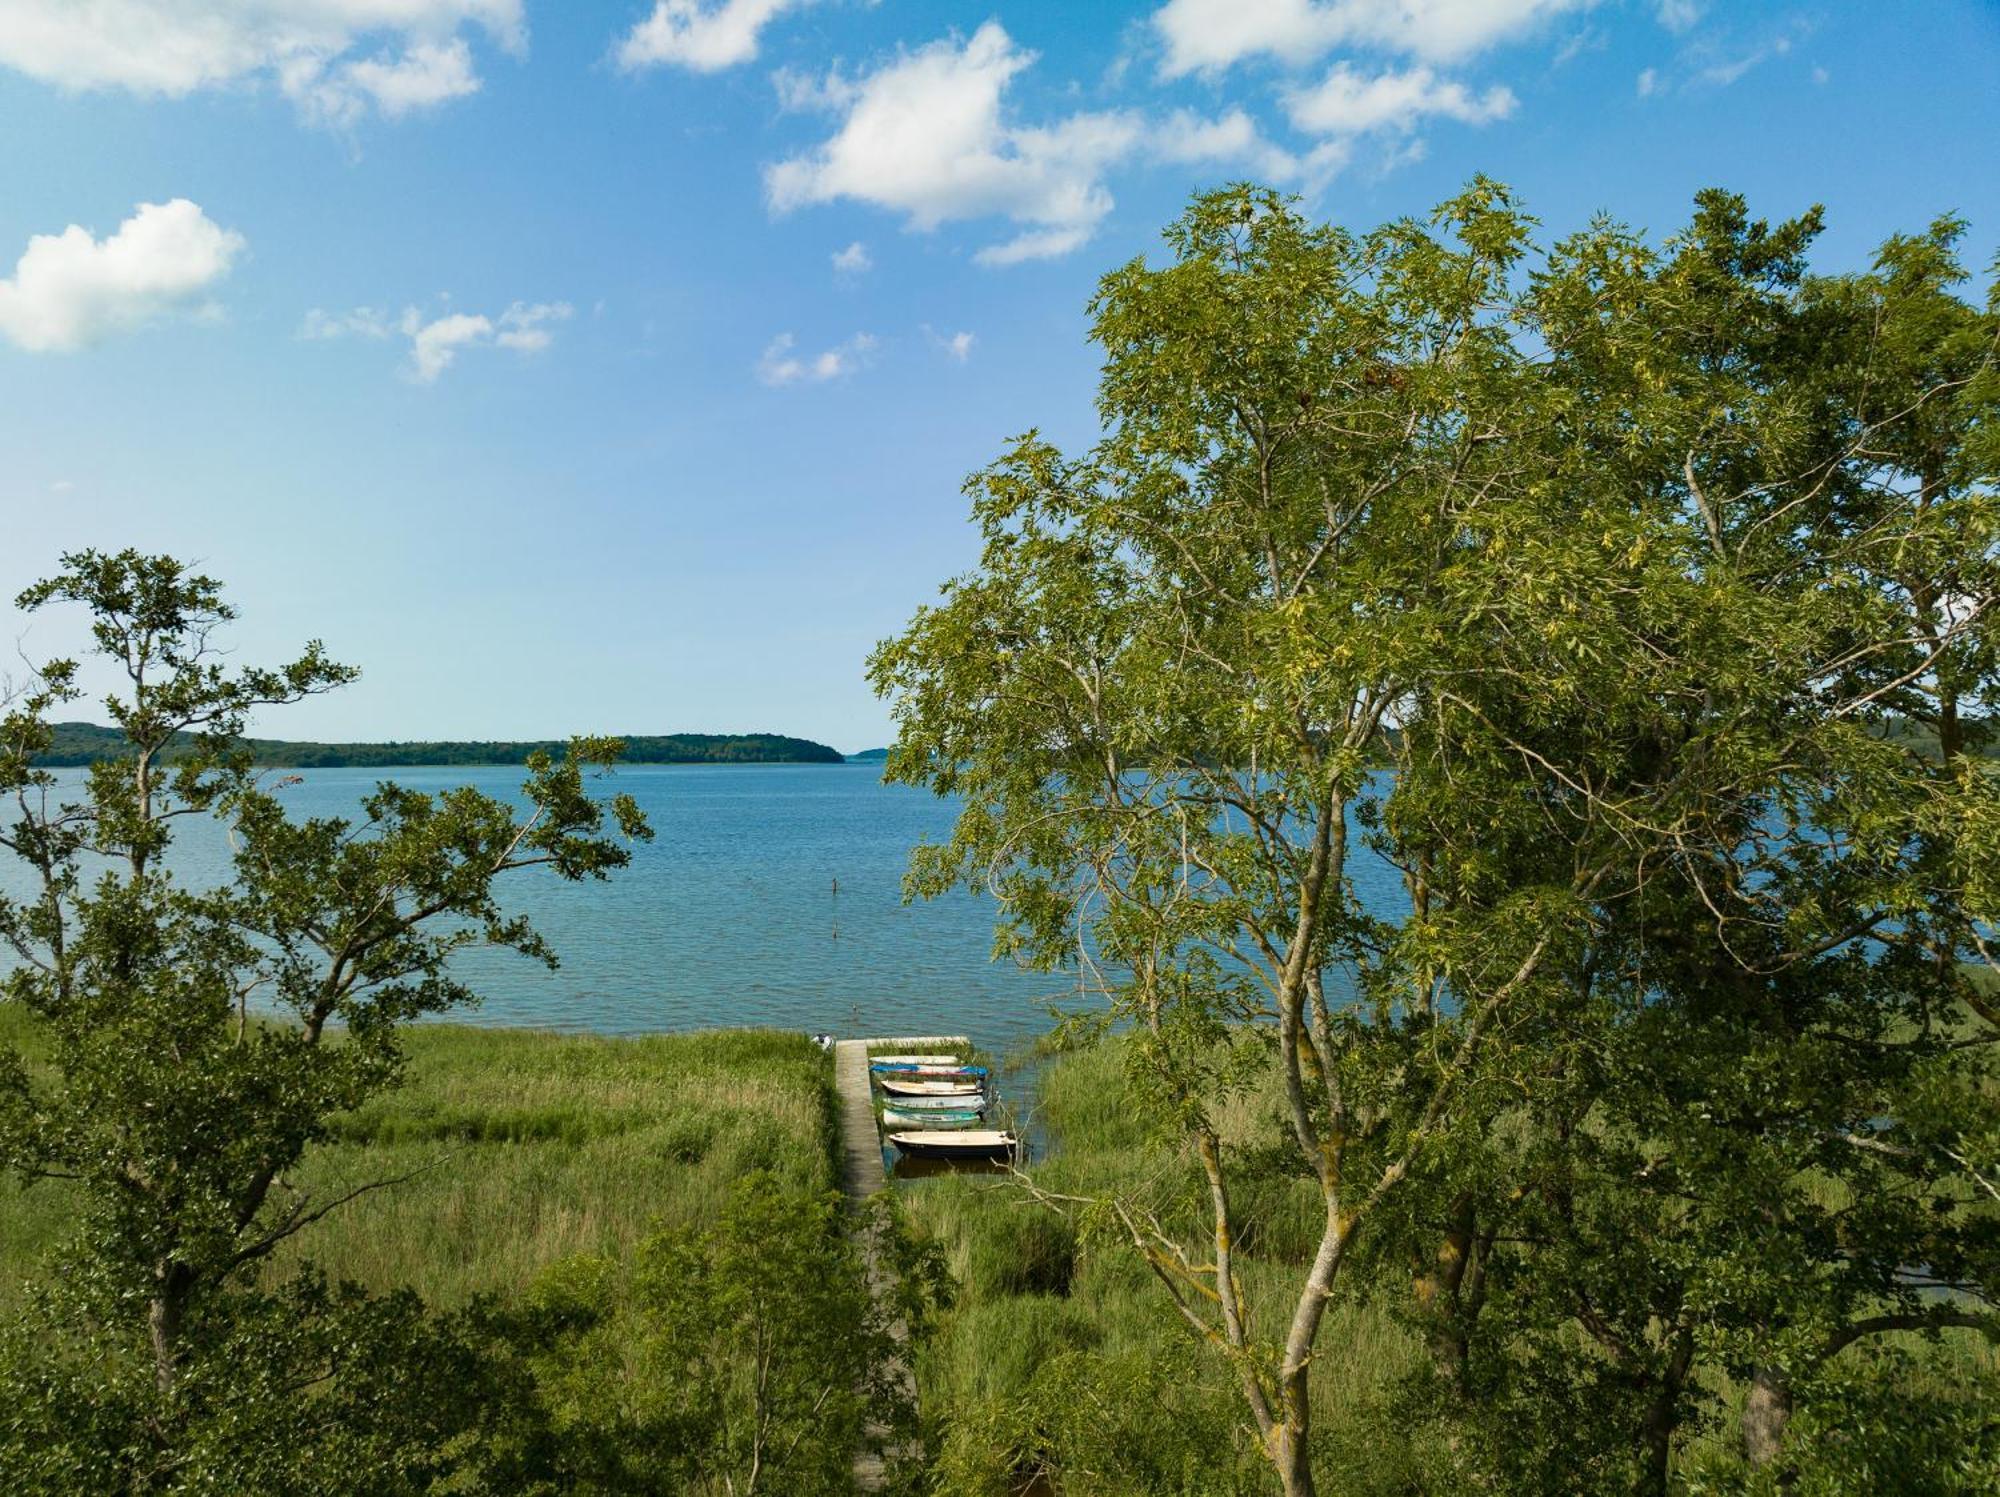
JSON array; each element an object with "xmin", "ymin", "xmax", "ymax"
[{"xmin": 0, "ymin": 1271, "xmax": 514, "ymax": 1497}]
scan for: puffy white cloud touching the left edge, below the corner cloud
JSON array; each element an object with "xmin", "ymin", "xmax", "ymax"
[{"xmin": 0, "ymin": 198, "xmax": 244, "ymax": 352}]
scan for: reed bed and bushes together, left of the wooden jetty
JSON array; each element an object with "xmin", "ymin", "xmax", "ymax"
[{"xmin": 0, "ymin": 1011, "xmax": 936, "ymax": 1495}]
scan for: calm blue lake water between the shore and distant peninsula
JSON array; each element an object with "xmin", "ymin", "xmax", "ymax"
[{"xmin": 0, "ymin": 765, "xmax": 1400, "ymax": 1053}]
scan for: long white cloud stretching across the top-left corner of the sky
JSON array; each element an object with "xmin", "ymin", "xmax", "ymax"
[{"xmin": 0, "ymin": 0, "xmax": 526, "ymax": 124}]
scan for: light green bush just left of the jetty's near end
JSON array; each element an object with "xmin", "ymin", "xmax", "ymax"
[{"xmin": 494, "ymin": 1173, "xmax": 922, "ymax": 1495}]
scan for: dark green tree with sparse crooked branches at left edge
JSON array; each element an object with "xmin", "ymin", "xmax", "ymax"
[{"xmin": 0, "ymin": 550, "xmax": 650, "ymax": 1489}]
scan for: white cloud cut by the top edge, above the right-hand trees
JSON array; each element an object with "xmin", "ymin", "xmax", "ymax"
[{"xmin": 1152, "ymin": 0, "xmax": 1594, "ymax": 78}]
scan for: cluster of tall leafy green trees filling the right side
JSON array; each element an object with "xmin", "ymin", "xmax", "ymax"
[{"xmin": 874, "ymin": 182, "xmax": 2000, "ymax": 1493}]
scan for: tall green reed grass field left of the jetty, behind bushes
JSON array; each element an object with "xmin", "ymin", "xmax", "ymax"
[{"xmin": 0, "ymin": 1005, "xmax": 834, "ymax": 1305}]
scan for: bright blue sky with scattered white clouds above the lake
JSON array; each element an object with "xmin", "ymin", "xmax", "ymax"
[{"xmin": 0, "ymin": 0, "xmax": 2000, "ymax": 749}]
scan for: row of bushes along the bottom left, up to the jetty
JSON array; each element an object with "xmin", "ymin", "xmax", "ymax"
[{"xmin": 0, "ymin": 1173, "xmax": 932, "ymax": 1497}]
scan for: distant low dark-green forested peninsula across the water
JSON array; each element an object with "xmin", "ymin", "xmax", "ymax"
[{"xmin": 34, "ymin": 722, "xmax": 846, "ymax": 769}]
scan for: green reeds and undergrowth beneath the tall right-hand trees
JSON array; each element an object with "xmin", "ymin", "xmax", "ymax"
[{"xmin": 908, "ymin": 1039, "xmax": 2000, "ymax": 1497}]
